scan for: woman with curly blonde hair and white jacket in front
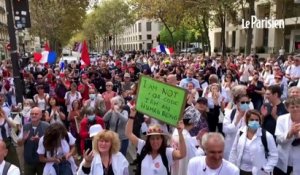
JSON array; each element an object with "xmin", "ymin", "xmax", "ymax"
[{"xmin": 77, "ymin": 130, "xmax": 129, "ymax": 175}]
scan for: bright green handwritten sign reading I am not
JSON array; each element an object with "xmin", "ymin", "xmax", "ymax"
[{"xmin": 136, "ymin": 75, "xmax": 187, "ymax": 126}]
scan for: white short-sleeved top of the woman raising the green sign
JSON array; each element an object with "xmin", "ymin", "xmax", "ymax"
[{"xmin": 137, "ymin": 139, "xmax": 174, "ymax": 175}]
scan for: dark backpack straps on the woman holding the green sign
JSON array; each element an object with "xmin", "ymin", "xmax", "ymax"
[{"xmin": 135, "ymin": 146, "xmax": 171, "ymax": 175}]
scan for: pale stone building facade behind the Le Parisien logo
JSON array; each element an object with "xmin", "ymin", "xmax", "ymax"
[{"xmin": 209, "ymin": 0, "xmax": 300, "ymax": 54}]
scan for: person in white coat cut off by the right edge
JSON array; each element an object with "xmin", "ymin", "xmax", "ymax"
[{"xmin": 274, "ymin": 97, "xmax": 300, "ymax": 175}]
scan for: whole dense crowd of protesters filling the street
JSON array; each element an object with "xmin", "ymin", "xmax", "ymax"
[{"xmin": 0, "ymin": 52, "xmax": 300, "ymax": 175}]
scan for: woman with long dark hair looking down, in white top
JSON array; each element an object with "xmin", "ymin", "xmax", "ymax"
[{"xmin": 37, "ymin": 122, "xmax": 77, "ymax": 175}]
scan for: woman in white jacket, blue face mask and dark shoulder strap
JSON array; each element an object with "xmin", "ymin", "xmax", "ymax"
[{"xmin": 229, "ymin": 110, "xmax": 278, "ymax": 175}]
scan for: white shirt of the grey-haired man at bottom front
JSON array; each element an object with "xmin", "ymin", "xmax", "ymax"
[{"xmin": 187, "ymin": 156, "xmax": 240, "ymax": 175}]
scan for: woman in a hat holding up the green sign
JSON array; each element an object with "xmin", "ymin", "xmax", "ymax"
[{"xmin": 125, "ymin": 107, "xmax": 186, "ymax": 175}]
